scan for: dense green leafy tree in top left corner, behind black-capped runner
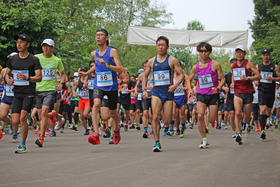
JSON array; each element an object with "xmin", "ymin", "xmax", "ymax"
[{"xmin": 0, "ymin": 0, "xmax": 67, "ymax": 66}]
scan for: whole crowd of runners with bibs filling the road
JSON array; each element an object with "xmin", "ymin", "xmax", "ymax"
[{"xmin": 0, "ymin": 29, "xmax": 280, "ymax": 153}]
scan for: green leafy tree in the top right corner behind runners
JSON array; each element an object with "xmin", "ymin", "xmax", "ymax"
[{"xmin": 248, "ymin": 0, "xmax": 280, "ymax": 63}]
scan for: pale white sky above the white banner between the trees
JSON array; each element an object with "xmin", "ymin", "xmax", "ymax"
[{"xmin": 158, "ymin": 0, "xmax": 255, "ymax": 47}]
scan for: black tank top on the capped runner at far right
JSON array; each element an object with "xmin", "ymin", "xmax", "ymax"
[{"xmin": 258, "ymin": 62, "xmax": 276, "ymax": 94}]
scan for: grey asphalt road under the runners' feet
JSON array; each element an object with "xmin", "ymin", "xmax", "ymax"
[{"xmin": 0, "ymin": 126, "xmax": 280, "ymax": 187}]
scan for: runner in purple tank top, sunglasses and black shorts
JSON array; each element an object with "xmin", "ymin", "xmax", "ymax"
[{"xmin": 187, "ymin": 42, "xmax": 225, "ymax": 149}]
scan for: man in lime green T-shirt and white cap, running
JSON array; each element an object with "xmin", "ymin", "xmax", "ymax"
[{"xmin": 35, "ymin": 38, "xmax": 66, "ymax": 147}]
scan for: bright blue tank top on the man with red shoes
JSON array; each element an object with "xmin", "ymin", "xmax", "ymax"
[{"xmin": 93, "ymin": 47, "xmax": 119, "ymax": 91}]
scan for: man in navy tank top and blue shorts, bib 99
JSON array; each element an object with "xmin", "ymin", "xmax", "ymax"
[{"xmin": 142, "ymin": 36, "xmax": 185, "ymax": 152}]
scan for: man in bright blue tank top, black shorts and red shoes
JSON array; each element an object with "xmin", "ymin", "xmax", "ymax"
[{"xmin": 88, "ymin": 29, "xmax": 123, "ymax": 145}]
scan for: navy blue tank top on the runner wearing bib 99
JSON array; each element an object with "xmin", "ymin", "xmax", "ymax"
[{"xmin": 153, "ymin": 55, "xmax": 174, "ymax": 90}]
